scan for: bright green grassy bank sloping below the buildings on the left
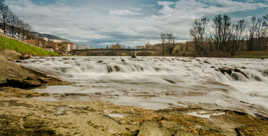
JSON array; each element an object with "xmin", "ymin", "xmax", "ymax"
[{"xmin": 0, "ymin": 36, "xmax": 58, "ymax": 56}]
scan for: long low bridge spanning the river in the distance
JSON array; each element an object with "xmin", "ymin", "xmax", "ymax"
[{"xmin": 71, "ymin": 49, "xmax": 157, "ymax": 56}]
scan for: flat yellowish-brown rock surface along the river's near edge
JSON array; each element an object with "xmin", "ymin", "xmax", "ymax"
[{"xmin": 0, "ymin": 88, "xmax": 268, "ymax": 136}]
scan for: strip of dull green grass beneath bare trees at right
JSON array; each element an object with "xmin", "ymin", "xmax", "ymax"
[{"xmin": 234, "ymin": 50, "xmax": 268, "ymax": 58}]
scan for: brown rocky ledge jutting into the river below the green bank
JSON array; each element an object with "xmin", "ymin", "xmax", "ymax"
[{"xmin": 0, "ymin": 51, "xmax": 68, "ymax": 89}]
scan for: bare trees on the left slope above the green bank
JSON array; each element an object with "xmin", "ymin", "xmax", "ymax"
[{"xmin": 0, "ymin": 0, "xmax": 31, "ymax": 40}]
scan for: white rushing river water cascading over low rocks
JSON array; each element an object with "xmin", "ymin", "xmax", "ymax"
[{"xmin": 19, "ymin": 57, "xmax": 268, "ymax": 115}]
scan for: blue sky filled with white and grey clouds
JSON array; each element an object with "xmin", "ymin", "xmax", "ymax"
[{"xmin": 6, "ymin": 0, "xmax": 268, "ymax": 47}]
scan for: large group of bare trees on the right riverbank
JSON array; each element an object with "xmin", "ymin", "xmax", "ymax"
[{"xmin": 190, "ymin": 15, "xmax": 268, "ymax": 56}]
